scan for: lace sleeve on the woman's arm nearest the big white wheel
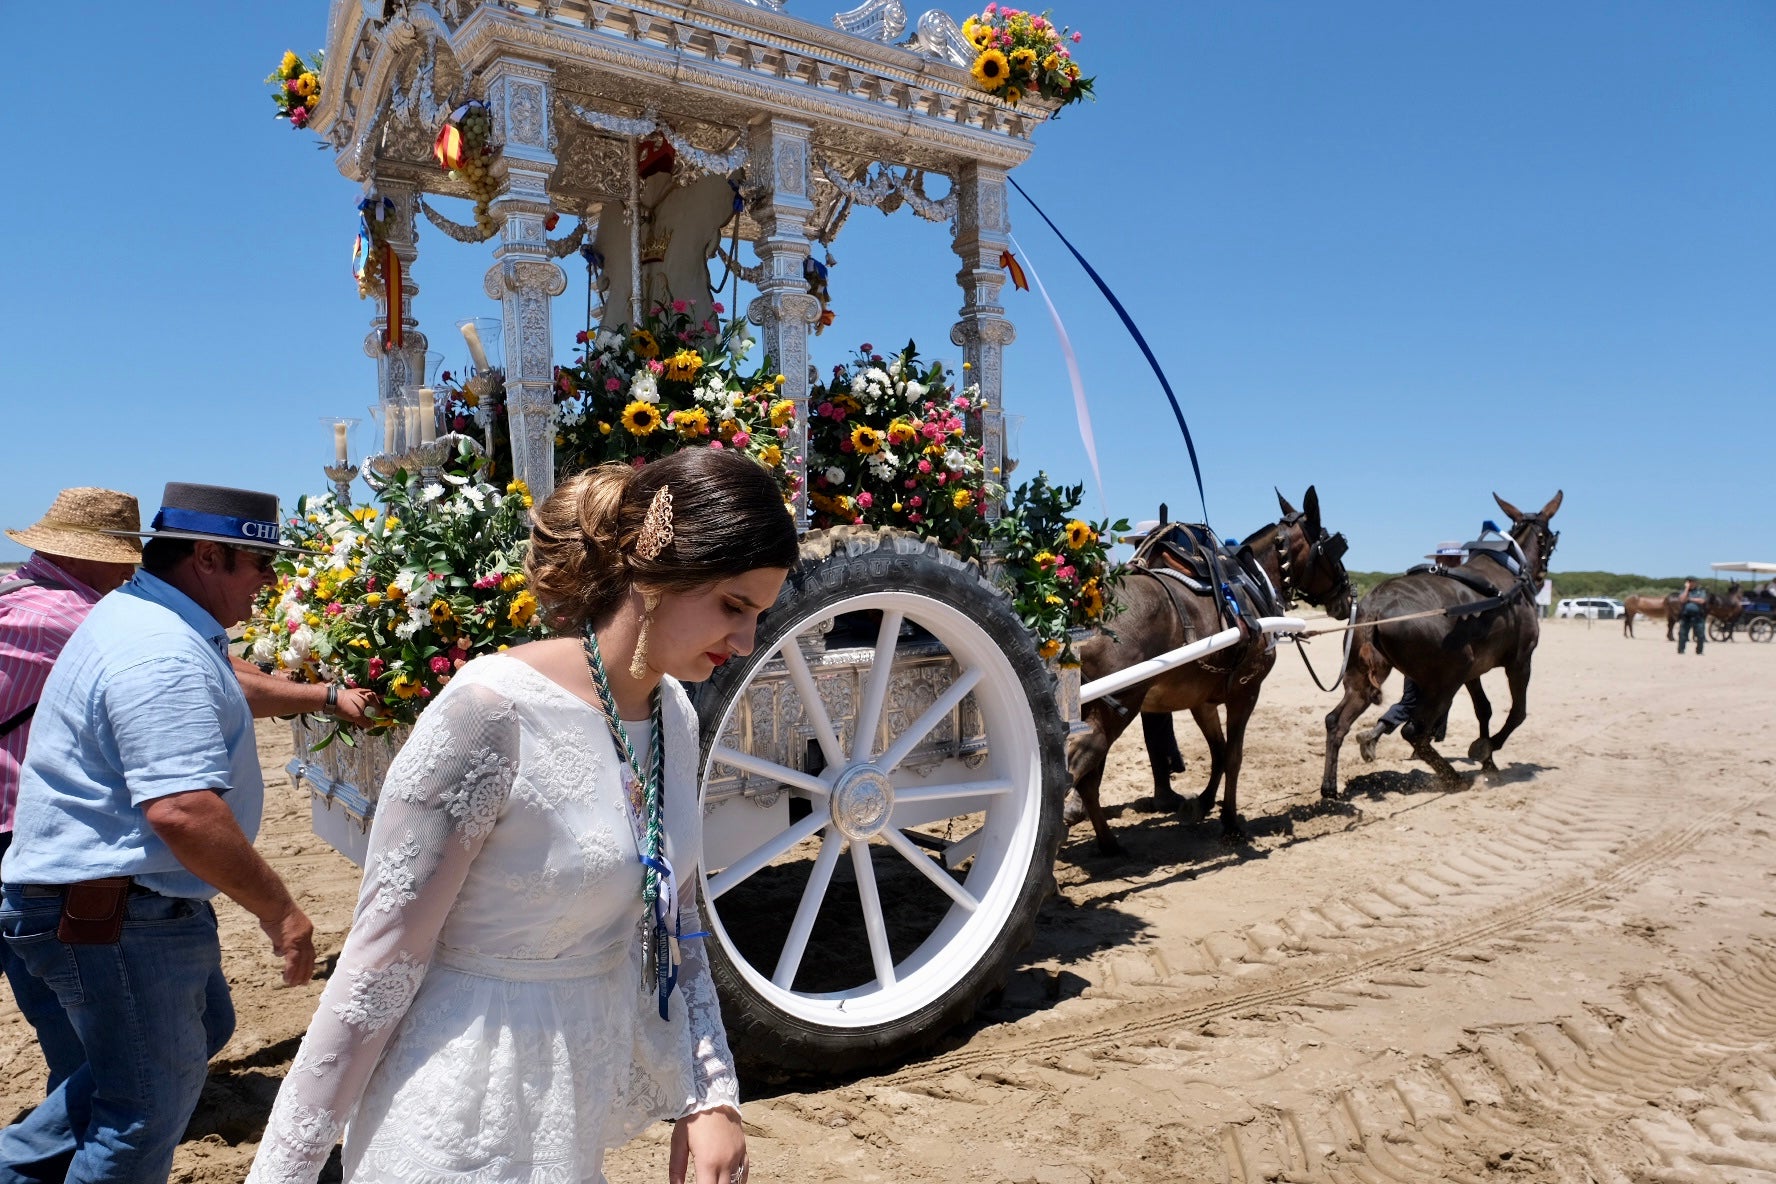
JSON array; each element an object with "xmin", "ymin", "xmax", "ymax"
[{"xmin": 668, "ymin": 692, "xmax": 741, "ymax": 1117}]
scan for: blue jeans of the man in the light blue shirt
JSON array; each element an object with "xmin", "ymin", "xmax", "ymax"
[{"xmin": 0, "ymin": 886, "xmax": 234, "ymax": 1184}]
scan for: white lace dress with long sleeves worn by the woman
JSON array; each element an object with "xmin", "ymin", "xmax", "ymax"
[{"xmin": 249, "ymin": 655, "xmax": 739, "ymax": 1184}]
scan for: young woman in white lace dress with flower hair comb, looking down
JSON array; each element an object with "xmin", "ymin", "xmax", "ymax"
[{"xmin": 249, "ymin": 449, "xmax": 797, "ymax": 1184}]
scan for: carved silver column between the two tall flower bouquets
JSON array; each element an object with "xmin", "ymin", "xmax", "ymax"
[{"xmin": 746, "ymin": 115, "xmax": 821, "ymax": 529}]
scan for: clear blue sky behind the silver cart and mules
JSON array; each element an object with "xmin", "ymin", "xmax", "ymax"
[{"xmin": 0, "ymin": 0, "xmax": 1776, "ymax": 575}]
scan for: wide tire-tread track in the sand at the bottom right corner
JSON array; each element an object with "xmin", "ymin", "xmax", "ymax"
[{"xmin": 1220, "ymin": 946, "xmax": 1776, "ymax": 1184}]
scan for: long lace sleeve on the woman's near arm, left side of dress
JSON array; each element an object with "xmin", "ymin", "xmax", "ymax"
[{"xmin": 247, "ymin": 680, "xmax": 519, "ymax": 1184}]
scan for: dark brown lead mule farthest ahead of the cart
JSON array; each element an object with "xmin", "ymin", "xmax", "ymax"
[{"xmin": 1320, "ymin": 493, "xmax": 1561, "ymax": 799}]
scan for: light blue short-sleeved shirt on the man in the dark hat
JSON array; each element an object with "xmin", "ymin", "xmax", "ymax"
[{"xmin": 0, "ymin": 572, "xmax": 265, "ymax": 900}]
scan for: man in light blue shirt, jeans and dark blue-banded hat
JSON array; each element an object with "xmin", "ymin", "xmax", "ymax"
[{"xmin": 0, "ymin": 483, "xmax": 314, "ymax": 1184}]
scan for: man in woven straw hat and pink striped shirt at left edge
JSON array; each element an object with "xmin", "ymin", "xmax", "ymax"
[{"xmin": 0, "ymin": 486, "xmax": 142, "ymax": 1090}]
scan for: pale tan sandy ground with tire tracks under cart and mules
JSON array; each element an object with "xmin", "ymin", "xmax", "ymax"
[{"xmin": 0, "ymin": 621, "xmax": 1776, "ymax": 1184}]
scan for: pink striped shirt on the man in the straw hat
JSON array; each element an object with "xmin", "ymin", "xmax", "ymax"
[{"xmin": 0, "ymin": 554, "xmax": 99, "ymax": 831}]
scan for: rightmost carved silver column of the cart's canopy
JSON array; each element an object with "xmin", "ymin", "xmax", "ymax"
[{"xmin": 950, "ymin": 163, "xmax": 1018, "ymax": 518}]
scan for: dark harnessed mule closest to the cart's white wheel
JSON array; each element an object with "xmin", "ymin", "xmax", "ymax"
[{"xmin": 1067, "ymin": 486, "xmax": 1352, "ymax": 854}]
